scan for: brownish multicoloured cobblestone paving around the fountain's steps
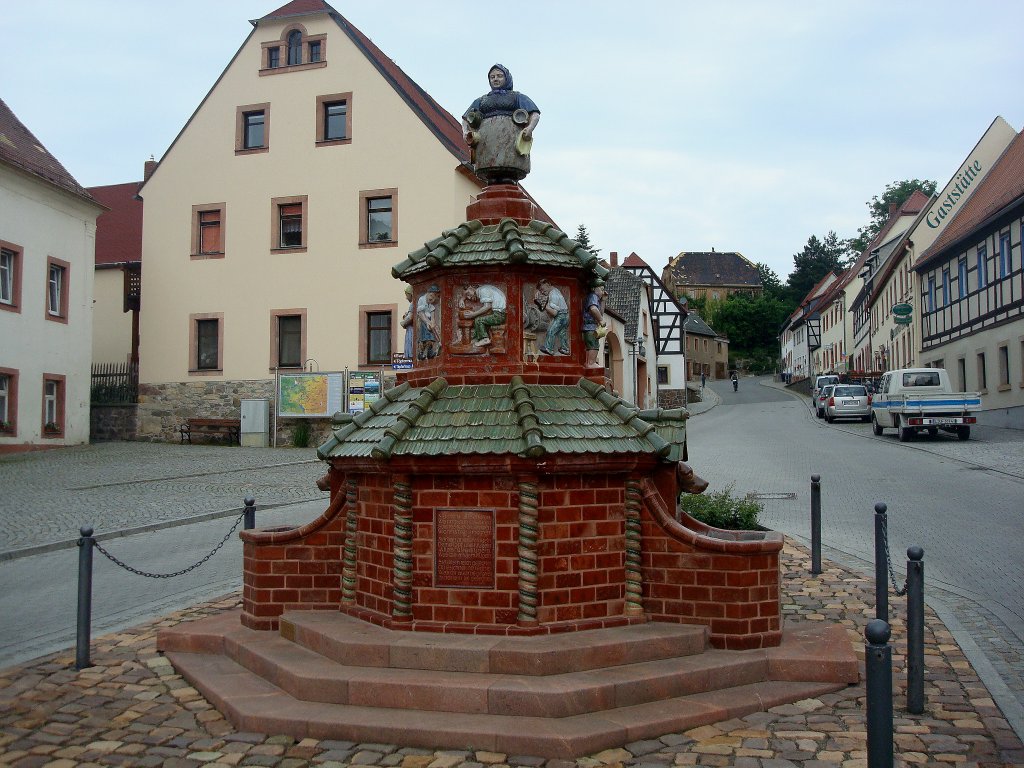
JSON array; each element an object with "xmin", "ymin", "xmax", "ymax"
[{"xmin": 0, "ymin": 541, "xmax": 1024, "ymax": 768}]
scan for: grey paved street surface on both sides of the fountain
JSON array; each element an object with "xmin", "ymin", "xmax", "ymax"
[{"xmin": 0, "ymin": 391, "xmax": 1024, "ymax": 732}]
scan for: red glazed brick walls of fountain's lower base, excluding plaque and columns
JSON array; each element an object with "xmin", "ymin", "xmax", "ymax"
[{"xmin": 242, "ymin": 466, "xmax": 781, "ymax": 648}]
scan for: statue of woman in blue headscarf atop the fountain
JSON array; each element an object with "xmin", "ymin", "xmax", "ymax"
[{"xmin": 462, "ymin": 65, "xmax": 541, "ymax": 184}]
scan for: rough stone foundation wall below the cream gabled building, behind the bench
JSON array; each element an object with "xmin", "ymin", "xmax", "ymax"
[{"xmin": 136, "ymin": 379, "xmax": 331, "ymax": 447}]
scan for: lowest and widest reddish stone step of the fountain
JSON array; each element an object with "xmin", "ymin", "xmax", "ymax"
[{"xmin": 167, "ymin": 651, "xmax": 843, "ymax": 759}]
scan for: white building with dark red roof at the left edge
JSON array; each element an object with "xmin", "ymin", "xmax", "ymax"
[{"xmin": 0, "ymin": 100, "xmax": 102, "ymax": 453}]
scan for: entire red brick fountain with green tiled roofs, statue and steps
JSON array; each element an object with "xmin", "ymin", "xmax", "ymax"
[{"xmin": 158, "ymin": 67, "xmax": 858, "ymax": 758}]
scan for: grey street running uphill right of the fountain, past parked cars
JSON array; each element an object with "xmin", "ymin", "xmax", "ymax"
[{"xmin": 687, "ymin": 378, "xmax": 1024, "ymax": 733}]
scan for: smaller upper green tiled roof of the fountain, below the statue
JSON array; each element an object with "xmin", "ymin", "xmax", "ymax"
[{"xmin": 391, "ymin": 219, "xmax": 608, "ymax": 280}]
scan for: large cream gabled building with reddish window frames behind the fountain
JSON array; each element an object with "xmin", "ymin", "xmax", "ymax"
[{"xmin": 138, "ymin": 0, "xmax": 485, "ymax": 442}]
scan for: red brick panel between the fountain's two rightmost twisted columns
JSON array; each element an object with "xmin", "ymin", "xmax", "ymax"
[{"xmin": 537, "ymin": 474, "xmax": 626, "ymax": 624}]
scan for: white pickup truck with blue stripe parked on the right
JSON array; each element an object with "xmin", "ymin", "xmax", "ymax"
[{"xmin": 871, "ymin": 368, "xmax": 981, "ymax": 442}]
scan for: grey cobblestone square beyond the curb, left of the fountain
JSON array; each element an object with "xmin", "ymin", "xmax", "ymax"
[{"xmin": 0, "ymin": 442, "xmax": 325, "ymax": 555}]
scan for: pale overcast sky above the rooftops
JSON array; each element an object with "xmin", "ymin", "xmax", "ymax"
[{"xmin": 0, "ymin": 0, "xmax": 1024, "ymax": 279}]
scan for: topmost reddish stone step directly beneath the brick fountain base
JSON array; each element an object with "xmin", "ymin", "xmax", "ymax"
[{"xmin": 281, "ymin": 611, "xmax": 709, "ymax": 675}]
